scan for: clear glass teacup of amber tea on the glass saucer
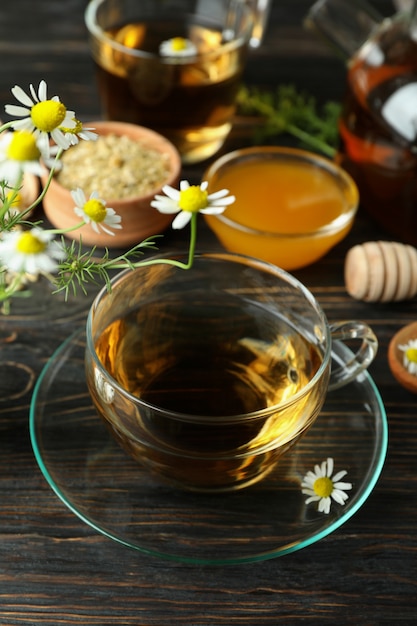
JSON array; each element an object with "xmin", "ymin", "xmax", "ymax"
[{"xmin": 85, "ymin": 253, "xmax": 377, "ymax": 492}]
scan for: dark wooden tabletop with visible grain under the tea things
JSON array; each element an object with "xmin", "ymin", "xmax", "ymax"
[{"xmin": 0, "ymin": 0, "xmax": 417, "ymax": 626}]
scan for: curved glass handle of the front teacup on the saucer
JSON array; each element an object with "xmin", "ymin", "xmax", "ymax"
[{"xmin": 328, "ymin": 320, "xmax": 378, "ymax": 391}]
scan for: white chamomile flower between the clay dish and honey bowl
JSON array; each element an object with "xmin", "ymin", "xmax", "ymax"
[{"xmin": 151, "ymin": 180, "xmax": 235, "ymax": 229}]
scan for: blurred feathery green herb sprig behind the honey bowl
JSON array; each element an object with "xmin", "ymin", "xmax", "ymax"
[{"xmin": 238, "ymin": 85, "xmax": 341, "ymax": 158}]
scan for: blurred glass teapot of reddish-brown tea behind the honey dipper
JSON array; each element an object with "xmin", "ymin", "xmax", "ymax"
[{"xmin": 306, "ymin": 0, "xmax": 417, "ymax": 246}]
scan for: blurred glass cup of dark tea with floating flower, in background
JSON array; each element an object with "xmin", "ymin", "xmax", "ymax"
[{"xmin": 85, "ymin": 0, "xmax": 270, "ymax": 163}]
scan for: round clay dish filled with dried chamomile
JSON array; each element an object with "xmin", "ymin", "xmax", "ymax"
[{"xmin": 41, "ymin": 121, "xmax": 181, "ymax": 248}]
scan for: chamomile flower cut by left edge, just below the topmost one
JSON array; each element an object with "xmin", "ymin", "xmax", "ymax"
[{"xmin": 0, "ymin": 130, "xmax": 43, "ymax": 185}]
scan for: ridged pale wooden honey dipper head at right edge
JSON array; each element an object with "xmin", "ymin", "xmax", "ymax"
[{"xmin": 345, "ymin": 241, "xmax": 417, "ymax": 302}]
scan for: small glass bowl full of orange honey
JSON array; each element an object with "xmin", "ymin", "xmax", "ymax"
[{"xmin": 203, "ymin": 146, "xmax": 359, "ymax": 270}]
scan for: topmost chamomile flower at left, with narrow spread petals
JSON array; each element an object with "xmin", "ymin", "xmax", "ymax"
[{"xmin": 6, "ymin": 80, "xmax": 76, "ymax": 156}]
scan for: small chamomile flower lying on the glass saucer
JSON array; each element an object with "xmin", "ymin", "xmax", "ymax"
[{"xmin": 301, "ymin": 457, "xmax": 352, "ymax": 514}]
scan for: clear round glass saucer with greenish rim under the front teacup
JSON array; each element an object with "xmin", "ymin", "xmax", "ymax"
[{"xmin": 30, "ymin": 330, "xmax": 388, "ymax": 564}]
